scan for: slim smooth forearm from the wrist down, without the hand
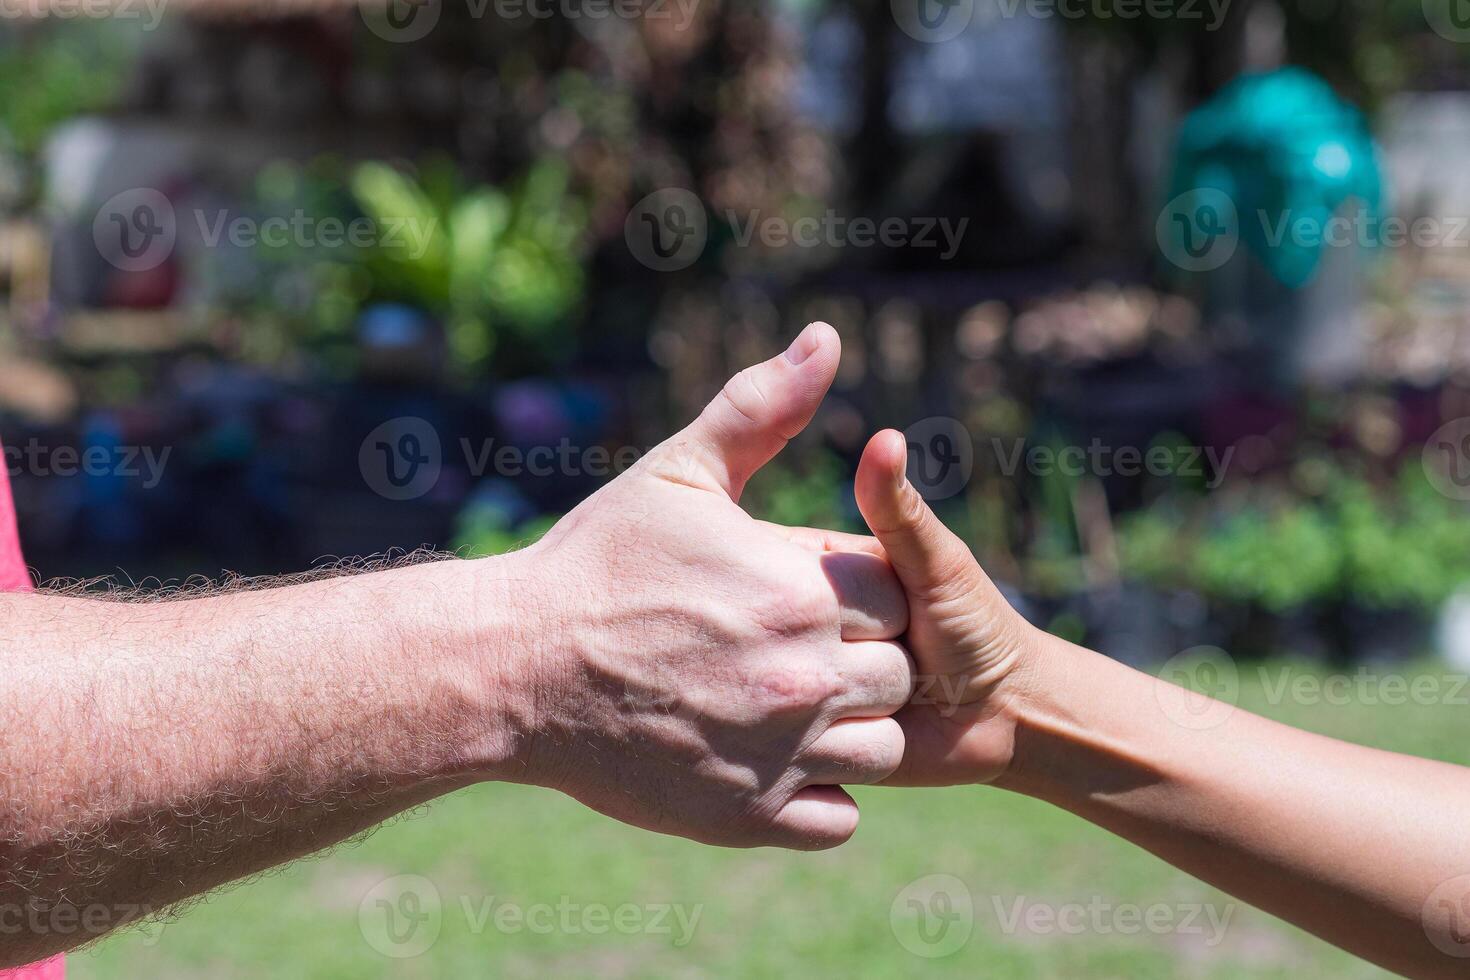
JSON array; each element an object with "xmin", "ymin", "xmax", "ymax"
[{"xmin": 1001, "ymin": 638, "xmax": 1470, "ymax": 977}]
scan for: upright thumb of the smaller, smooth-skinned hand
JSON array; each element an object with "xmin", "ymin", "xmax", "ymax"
[{"xmin": 857, "ymin": 429, "xmax": 979, "ymax": 597}]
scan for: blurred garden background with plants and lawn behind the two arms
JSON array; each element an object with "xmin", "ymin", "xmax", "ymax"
[{"xmin": 0, "ymin": 0, "xmax": 1470, "ymax": 977}]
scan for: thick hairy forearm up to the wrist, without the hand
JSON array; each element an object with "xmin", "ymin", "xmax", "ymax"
[{"xmin": 0, "ymin": 560, "xmax": 531, "ymax": 965}]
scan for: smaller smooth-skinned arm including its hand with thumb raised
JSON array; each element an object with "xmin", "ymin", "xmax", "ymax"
[{"xmin": 857, "ymin": 432, "xmax": 1470, "ymax": 977}]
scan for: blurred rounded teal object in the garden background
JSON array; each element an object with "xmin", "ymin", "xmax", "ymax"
[{"xmin": 1169, "ymin": 68, "xmax": 1382, "ymax": 288}]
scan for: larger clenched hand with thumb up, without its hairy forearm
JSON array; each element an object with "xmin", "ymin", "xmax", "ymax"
[{"xmin": 516, "ymin": 323, "xmax": 911, "ymax": 849}]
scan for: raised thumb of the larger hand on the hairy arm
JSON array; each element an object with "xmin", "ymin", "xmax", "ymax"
[{"xmin": 670, "ymin": 323, "xmax": 842, "ymax": 501}]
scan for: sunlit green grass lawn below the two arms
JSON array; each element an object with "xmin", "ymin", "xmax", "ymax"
[{"xmin": 71, "ymin": 667, "xmax": 1470, "ymax": 980}]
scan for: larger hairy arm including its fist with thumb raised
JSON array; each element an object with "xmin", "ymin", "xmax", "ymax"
[{"xmin": 0, "ymin": 325, "xmax": 911, "ymax": 967}]
